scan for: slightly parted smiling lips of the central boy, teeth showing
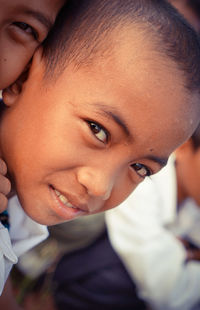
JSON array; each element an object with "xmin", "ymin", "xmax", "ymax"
[{"xmin": 49, "ymin": 185, "xmax": 88, "ymax": 220}]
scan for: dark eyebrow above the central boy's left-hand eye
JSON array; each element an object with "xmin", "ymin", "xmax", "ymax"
[{"xmin": 95, "ymin": 103, "xmax": 131, "ymax": 137}]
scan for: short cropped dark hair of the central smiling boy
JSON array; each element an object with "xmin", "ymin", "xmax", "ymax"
[{"xmin": 44, "ymin": 0, "xmax": 200, "ymax": 92}]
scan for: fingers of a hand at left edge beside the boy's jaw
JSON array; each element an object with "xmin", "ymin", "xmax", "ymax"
[{"xmin": 0, "ymin": 158, "xmax": 11, "ymax": 213}]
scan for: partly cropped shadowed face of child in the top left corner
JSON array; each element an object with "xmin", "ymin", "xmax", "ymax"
[{"xmin": 0, "ymin": 0, "xmax": 64, "ymax": 89}]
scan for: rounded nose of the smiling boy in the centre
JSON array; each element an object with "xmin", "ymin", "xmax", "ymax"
[{"xmin": 77, "ymin": 167, "xmax": 114, "ymax": 200}]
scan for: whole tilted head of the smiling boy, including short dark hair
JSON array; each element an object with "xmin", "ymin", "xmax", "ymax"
[{"xmin": 0, "ymin": 0, "xmax": 200, "ymax": 225}]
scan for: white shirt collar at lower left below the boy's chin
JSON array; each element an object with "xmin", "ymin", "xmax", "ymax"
[{"xmin": 0, "ymin": 196, "xmax": 48, "ymax": 295}]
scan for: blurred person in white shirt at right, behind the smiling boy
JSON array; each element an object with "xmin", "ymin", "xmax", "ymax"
[{"xmin": 106, "ymin": 127, "xmax": 200, "ymax": 310}]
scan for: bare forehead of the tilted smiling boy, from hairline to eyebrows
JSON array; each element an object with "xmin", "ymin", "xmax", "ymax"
[{"xmin": 23, "ymin": 29, "xmax": 197, "ymax": 157}]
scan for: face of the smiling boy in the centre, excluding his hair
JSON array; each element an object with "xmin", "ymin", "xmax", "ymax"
[{"xmin": 0, "ymin": 31, "xmax": 198, "ymax": 225}]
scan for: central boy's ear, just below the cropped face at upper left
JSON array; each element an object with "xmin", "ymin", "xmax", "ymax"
[{"xmin": 2, "ymin": 48, "xmax": 42, "ymax": 107}]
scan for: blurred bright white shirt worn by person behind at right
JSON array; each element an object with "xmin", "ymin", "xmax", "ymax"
[{"xmin": 106, "ymin": 162, "xmax": 200, "ymax": 310}]
